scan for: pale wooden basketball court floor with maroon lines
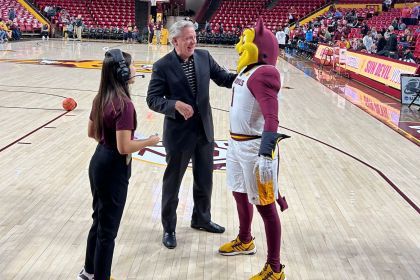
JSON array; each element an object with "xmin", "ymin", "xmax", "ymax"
[{"xmin": 0, "ymin": 41, "xmax": 420, "ymax": 280}]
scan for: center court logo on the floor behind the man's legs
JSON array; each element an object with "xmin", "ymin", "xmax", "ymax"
[{"xmin": 132, "ymin": 140, "xmax": 228, "ymax": 170}]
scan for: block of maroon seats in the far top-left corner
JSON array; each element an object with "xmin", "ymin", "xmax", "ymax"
[{"xmin": 0, "ymin": 0, "xmax": 41, "ymax": 33}]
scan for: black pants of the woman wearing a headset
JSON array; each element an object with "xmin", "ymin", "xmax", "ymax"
[{"xmin": 85, "ymin": 145, "xmax": 131, "ymax": 280}]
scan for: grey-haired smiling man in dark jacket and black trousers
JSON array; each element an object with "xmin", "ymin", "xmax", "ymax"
[{"xmin": 147, "ymin": 21, "xmax": 236, "ymax": 249}]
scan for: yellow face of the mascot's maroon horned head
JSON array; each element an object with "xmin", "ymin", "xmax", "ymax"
[{"xmin": 235, "ymin": 29, "xmax": 258, "ymax": 73}]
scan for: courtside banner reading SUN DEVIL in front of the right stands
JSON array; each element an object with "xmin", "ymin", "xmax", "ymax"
[{"xmin": 315, "ymin": 45, "xmax": 418, "ymax": 90}]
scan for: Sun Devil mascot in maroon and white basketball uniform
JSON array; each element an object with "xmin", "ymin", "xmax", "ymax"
[{"xmin": 219, "ymin": 19, "xmax": 289, "ymax": 280}]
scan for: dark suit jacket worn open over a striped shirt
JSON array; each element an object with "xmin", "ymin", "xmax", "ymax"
[{"xmin": 146, "ymin": 49, "xmax": 236, "ymax": 151}]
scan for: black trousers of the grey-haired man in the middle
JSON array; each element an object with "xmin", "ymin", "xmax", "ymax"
[{"xmin": 162, "ymin": 131, "xmax": 214, "ymax": 232}]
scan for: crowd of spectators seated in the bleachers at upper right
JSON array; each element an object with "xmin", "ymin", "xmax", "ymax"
[{"xmin": 290, "ymin": 3, "xmax": 420, "ymax": 62}]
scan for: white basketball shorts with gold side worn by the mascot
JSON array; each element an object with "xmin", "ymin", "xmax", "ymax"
[{"xmin": 226, "ymin": 139, "xmax": 278, "ymax": 205}]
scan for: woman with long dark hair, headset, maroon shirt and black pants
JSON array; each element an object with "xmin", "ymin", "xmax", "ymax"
[{"xmin": 78, "ymin": 49, "xmax": 159, "ymax": 280}]
